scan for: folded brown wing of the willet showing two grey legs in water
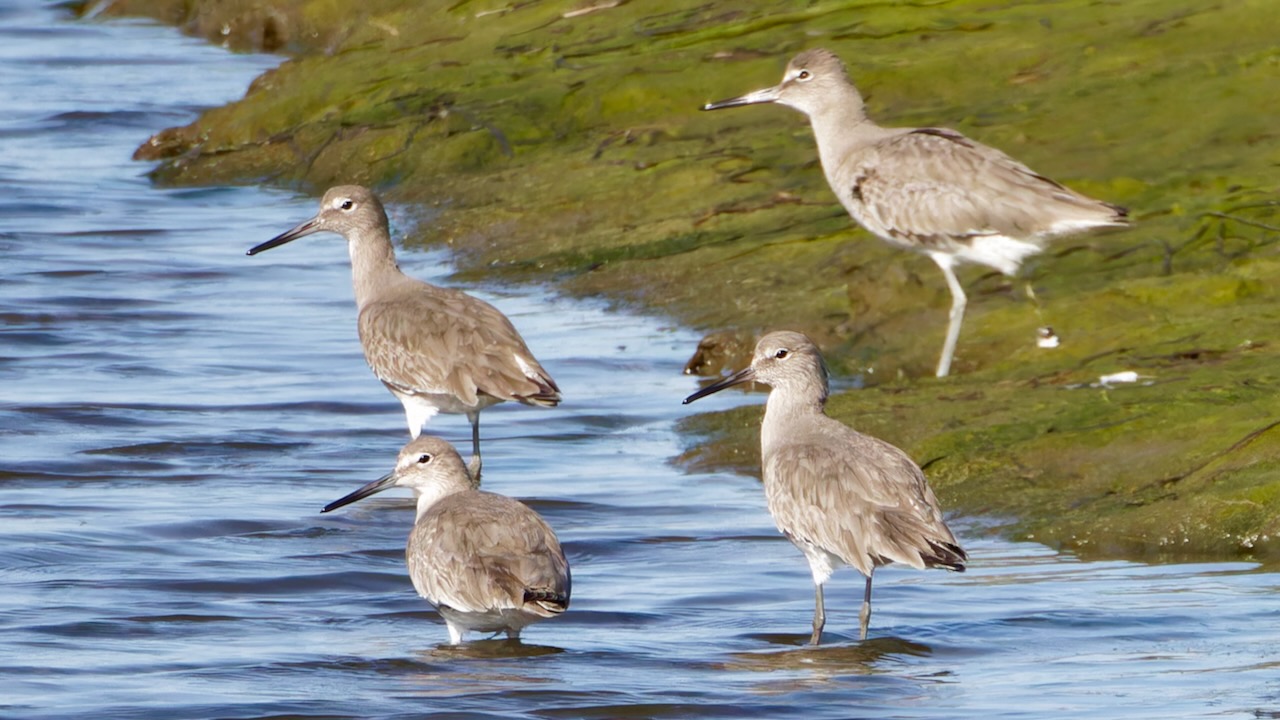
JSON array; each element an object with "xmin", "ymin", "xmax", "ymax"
[{"xmin": 764, "ymin": 433, "xmax": 964, "ymax": 574}]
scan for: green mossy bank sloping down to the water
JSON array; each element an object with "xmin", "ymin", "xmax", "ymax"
[{"xmin": 85, "ymin": 0, "xmax": 1280, "ymax": 560}]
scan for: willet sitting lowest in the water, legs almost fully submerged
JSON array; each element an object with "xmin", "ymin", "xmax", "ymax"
[{"xmin": 321, "ymin": 436, "xmax": 571, "ymax": 644}]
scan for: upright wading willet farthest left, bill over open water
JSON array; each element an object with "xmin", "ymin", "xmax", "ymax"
[{"xmin": 248, "ymin": 184, "xmax": 561, "ymax": 479}]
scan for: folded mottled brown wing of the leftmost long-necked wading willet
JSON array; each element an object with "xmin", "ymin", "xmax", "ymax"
[{"xmin": 360, "ymin": 286, "xmax": 559, "ymax": 405}]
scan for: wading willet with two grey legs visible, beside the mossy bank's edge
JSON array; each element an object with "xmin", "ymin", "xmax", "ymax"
[{"xmin": 685, "ymin": 332, "xmax": 966, "ymax": 644}]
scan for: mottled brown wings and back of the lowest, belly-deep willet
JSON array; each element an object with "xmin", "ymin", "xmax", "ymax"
[{"xmin": 407, "ymin": 491, "xmax": 572, "ymax": 616}]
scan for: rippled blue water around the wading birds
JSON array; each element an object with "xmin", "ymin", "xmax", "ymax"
[{"xmin": 0, "ymin": 4, "xmax": 1280, "ymax": 719}]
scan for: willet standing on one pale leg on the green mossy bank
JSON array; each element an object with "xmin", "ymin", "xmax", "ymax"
[{"xmin": 703, "ymin": 50, "xmax": 1128, "ymax": 378}]
